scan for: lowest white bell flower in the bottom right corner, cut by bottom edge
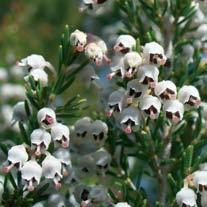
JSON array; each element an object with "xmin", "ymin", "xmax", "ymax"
[{"xmin": 176, "ymin": 187, "xmax": 197, "ymax": 207}]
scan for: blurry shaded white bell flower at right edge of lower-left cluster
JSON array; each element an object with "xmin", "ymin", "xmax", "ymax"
[{"xmin": 54, "ymin": 148, "xmax": 72, "ymax": 176}]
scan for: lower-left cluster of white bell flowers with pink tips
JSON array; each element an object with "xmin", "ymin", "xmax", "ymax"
[{"xmin": 3, "ymin": 107, "xmax": 70, "ymax": 191}]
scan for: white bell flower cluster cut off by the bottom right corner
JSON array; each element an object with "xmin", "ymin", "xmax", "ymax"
[{"xmin": 176, "ymin": 163, "xmax": 207, "ymax": 207}]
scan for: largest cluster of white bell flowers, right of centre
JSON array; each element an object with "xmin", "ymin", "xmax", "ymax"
[{"xmin": 107, "ymin": 35, "xmax": 201, "ymax": 134}]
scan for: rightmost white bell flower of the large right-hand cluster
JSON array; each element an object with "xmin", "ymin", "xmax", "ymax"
[{"xmin": 178, "ymin": 85, "xmax": 201, "ymax": 110}]
